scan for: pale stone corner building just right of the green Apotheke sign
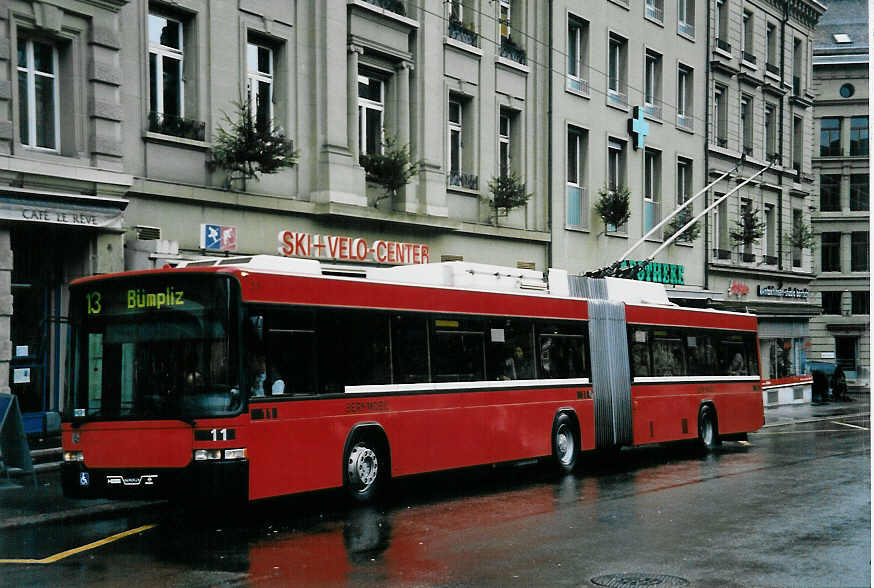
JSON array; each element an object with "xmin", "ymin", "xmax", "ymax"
[{"xmin": 706, "ymin": 0, "xmax": 826, "ymax": 403}]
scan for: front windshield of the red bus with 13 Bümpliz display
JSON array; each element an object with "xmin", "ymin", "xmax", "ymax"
[{"xmin": 65, "ymin": 274, "xmax": 241, "ymax": 420}]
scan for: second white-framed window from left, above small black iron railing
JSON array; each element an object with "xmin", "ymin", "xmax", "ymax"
[{"xmin": 149, "ymin": 14, "xmax": 185, "ymax": 118}]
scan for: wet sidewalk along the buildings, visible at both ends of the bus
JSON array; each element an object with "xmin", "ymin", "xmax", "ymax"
[{"xmin": 0, "ymin": 392, "xmax": 871, "ymax": 530}]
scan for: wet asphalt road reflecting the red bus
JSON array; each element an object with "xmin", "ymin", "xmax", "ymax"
[{"xmin": 0, "ymin": 417, "xmax": 871, "ymax": 586}]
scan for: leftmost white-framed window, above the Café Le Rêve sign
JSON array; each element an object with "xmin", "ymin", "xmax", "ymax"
[{"xmin": 18, "ymin": 38, "xmax": 61, "ymax": 151}]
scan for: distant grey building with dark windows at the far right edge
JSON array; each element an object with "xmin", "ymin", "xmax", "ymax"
[{"xmin": 810, "ymin": 0, "xmax": 871, "ymax": 385}]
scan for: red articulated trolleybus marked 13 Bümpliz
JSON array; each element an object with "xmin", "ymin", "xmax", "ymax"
[{"xmin": 62, "ymin": 255, "xmax": 763, "ymax": 501}]
